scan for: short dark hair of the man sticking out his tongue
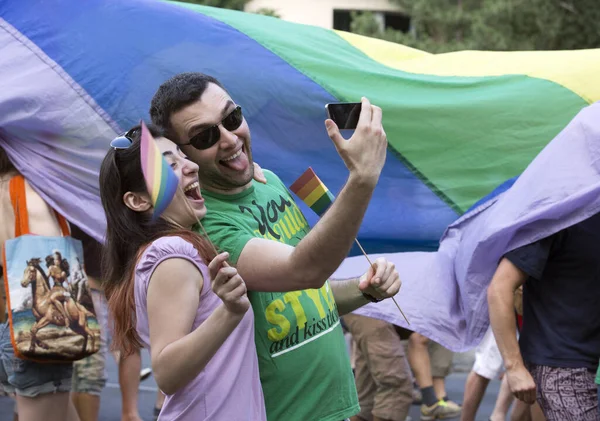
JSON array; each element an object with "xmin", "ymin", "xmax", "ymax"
[{"xmin": 150, "ymin": 72, "xmax": 225, "ymax": 139}]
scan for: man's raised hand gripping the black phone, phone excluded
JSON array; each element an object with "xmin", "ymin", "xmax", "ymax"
[{"xmin": 325, "ymin": 97, "xmax": 387, "ymax": 185}]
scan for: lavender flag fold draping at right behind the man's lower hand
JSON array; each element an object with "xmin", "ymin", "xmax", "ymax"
[{"xmin": 334, "ymin": 102, "xmax": 600, "ymax": 352}]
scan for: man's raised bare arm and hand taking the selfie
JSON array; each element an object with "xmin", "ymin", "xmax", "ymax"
[{"xmin": 236, "ymin": 98, "xmax": 387, "ymax": 291}]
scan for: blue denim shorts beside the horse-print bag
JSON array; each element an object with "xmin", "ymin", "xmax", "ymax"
[{"xmin": 0, "ymin": 323, "xmax": 73, "ymax": 398}]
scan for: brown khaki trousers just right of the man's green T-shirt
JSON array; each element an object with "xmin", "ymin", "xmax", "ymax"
[{"xmin": 342, "ymin": 314, "xmax": 413, "ymax": 421}]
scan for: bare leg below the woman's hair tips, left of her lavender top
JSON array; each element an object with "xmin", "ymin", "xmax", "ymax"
[{"xmin": 119, "ymin": 352, "xmax": 142, "ymax": 421}]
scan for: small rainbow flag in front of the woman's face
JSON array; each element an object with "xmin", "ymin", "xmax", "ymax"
[{"xmin": 140, "ymin": 121, "xmax": 179, "ymax": 220}]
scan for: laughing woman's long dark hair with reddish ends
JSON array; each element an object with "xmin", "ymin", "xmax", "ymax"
[{"xmin": 100, "ymin": 126, "xmax": 214, "ymax": 356}]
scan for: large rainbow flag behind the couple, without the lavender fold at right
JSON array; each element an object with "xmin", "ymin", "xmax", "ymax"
[{"xmin": 0, "ymin": 0, "xmax": 600, "ymax": 348}]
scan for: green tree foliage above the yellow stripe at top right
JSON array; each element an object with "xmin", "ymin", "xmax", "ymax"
[{"xmin": 351, "ymin": 0, "xmax": 600, "ymax": 53}]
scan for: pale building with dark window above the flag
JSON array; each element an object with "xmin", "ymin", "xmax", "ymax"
[{"xmin": 245, "ymin": 0, "xmax": 410, "ymax": 32}]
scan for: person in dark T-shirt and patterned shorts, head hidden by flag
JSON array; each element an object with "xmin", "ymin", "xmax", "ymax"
[{"xmin": 488, "ymin": 217, "xmax": 600, "ymax": 421}]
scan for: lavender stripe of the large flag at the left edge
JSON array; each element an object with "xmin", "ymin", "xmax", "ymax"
[{"xmin": 0, "ymin": 18, "xmax": 118, "ymax": 241}]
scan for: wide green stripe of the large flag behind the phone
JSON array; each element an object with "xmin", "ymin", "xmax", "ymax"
[{"xmin": 176, "ymin": 4, "xmax": 588, "ymax": 213}]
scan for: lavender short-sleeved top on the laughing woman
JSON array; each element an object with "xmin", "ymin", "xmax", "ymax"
[{"xmin": 135, "ymin": 236, "xmax": 266, "ymax": 421}]
